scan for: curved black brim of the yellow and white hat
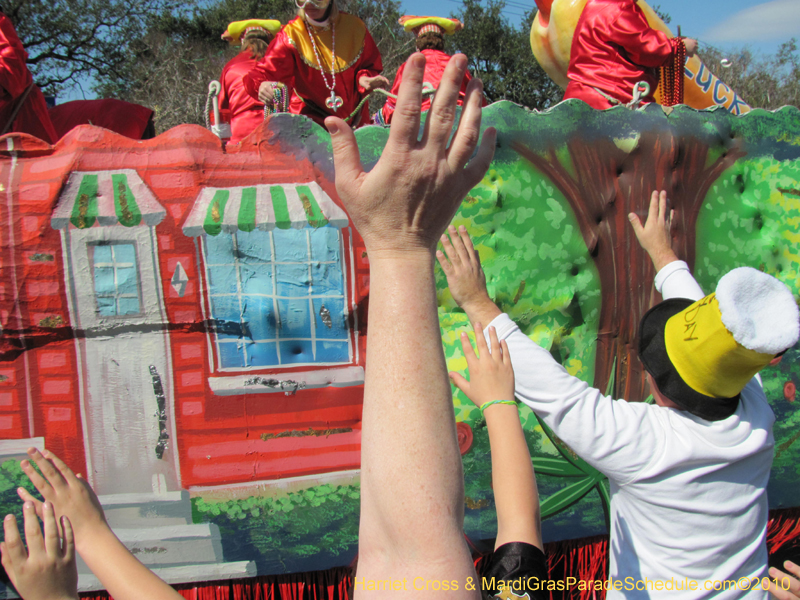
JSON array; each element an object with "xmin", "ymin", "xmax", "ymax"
[{"xmin": 639, "ymin": 298, "xmax": 739, "ymax": 421}]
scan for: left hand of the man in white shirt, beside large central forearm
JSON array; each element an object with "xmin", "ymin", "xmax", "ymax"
[{"xmin": 436, "ymin": 225, "xmax": 491, "ymax": 312}]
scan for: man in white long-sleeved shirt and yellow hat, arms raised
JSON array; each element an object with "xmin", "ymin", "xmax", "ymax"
[{"xmin": 437, "ymin": 192, "xmax": 800, "ymax": 598}]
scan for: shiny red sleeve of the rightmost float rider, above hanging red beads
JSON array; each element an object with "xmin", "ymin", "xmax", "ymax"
[{"xmin": 608, "ymin": 4, "xmax": 672, "ymax": 67}]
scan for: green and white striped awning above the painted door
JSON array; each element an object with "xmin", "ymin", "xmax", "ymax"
[{"xmin": 50, "ymin": 169, "xmax": 166, "ymax": 229}]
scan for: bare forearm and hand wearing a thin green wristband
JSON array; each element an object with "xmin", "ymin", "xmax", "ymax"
[{"xmin": 450, "ymin": 323, "xmax": 543, "ymax": 550}]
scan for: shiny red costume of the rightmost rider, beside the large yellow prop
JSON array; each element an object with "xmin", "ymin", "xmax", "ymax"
[{"xmin": 564, "ymin": 0, "xmax": 679, "ymax": 109}]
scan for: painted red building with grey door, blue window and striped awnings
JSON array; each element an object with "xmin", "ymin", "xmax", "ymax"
[{"xmin": 0, "ymin": 118, "xmax": 368, "ymax": 502}]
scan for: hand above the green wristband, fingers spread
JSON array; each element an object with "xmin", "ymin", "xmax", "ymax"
[{"xmin": 450, "ymin": 323, "xmax": 514, "ymax": 408}]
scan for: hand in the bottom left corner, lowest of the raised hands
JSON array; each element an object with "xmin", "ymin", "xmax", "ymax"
[{"xmin": 0, "ymin": 502, "xmax": 78, "ymax": 600}]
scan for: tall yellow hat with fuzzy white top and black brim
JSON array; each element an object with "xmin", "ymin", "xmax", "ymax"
[{"xmin": 639, "ymin": 267, "xmax": 800, "ymax": 421}]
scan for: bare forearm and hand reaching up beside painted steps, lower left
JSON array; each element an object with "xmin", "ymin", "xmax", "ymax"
[{"xmin": 17, "ymin": 448, "xmax": 182, "ymax": 600}]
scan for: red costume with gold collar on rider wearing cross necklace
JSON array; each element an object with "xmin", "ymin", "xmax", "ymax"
[{"xmin": 243, "ymin": 13, "xmax": 383, "ymax": 125}]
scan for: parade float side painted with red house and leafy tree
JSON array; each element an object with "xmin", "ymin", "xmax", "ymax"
[{"xmin": 0, "ymin": 0, "xmax": 800, "ymax": 598}]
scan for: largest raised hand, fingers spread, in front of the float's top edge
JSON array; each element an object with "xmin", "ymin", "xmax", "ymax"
[{"xmin": 325, "ymin": 53, "xmax": 496, "ymax": 260}]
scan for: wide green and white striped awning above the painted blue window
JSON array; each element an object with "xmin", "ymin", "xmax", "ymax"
[{"xmin": 183, "ymin": 181, "xmax": 348, "ymax": 237}]
